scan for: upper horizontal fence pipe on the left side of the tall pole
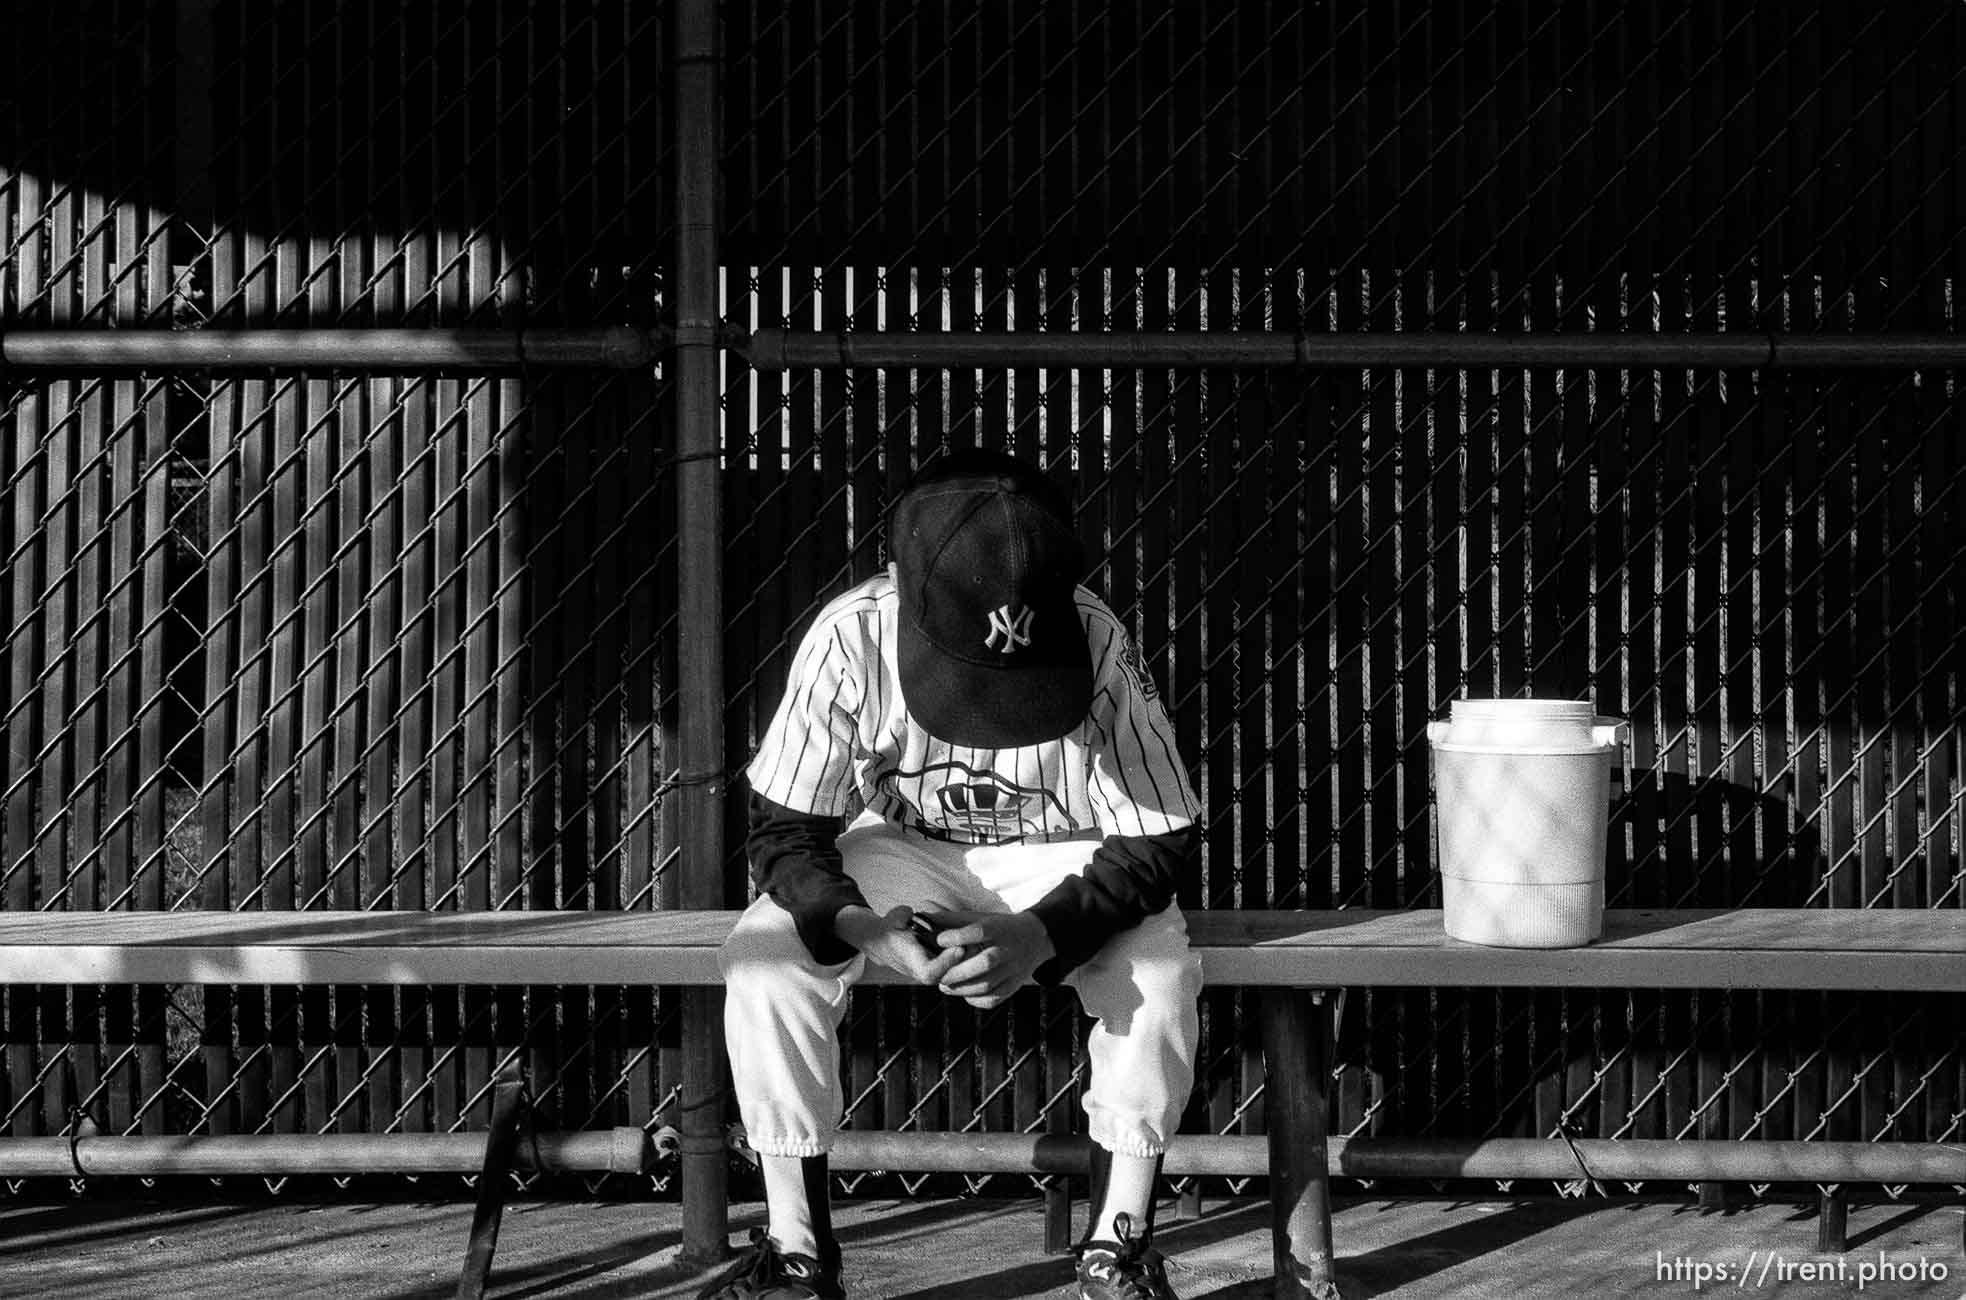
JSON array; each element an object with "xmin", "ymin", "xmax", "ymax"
[{"xmin": 0, "ymin": 326, "xmax": 668, "ymax": 370}]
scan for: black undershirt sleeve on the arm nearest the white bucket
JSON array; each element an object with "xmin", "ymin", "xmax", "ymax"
[{"xmin": 1030, "ymin": 826, "xmax": 1201, "ymax": 983}]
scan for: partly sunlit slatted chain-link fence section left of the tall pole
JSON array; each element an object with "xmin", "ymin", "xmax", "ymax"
[{"xmin": 0, "ymin": 2, "xmax": 674, "ymax": 1156}]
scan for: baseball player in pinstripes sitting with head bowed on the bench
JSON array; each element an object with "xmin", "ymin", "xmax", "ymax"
[{"xmin": 704, "ymin": 450, "xmax": 1201, "ymax": 1300}]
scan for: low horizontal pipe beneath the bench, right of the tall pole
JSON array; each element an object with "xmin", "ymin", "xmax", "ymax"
[{"xmin": 813, "ymin": 1131, "xmax": 1966, "ymax": 1184}]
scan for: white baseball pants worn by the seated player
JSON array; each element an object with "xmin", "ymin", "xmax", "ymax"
[{"xmin": 722, "ymin": 814, "xmax": 1201, "ymax": 1156}]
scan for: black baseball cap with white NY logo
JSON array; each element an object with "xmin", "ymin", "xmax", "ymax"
[{"xmin": 887, "ymin": 448, "xmax": 1093, "ymax": 749}]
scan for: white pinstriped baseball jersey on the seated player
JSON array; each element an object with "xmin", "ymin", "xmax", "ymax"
[{"xmin": 745, "ymin": 572, "xmax": 1201, "ymax": 844}]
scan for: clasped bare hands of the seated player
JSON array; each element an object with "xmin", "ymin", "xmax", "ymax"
[{"xmin": 834, "ymin": 905, "xmax": 1056, "ymax": 1011}]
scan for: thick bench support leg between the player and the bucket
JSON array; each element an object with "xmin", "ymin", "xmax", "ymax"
[{"xmin": 1260, "ymin": 989, "xmax": 1339, "ymax": 1300}]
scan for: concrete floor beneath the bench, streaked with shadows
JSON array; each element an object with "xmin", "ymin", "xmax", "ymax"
[{"xmin": 0, "ymin": 1194, "xmax": 1966, "ymax": 1300}]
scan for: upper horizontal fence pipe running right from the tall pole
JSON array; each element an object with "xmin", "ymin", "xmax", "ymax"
[{"xmin": 731, "ymin": 330, "xmax": 1966, "ymax": 370}]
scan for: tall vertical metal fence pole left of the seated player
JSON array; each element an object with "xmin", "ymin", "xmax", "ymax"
[{"xmin": 668, "ymin": 0, "xmax": 729, "ymax": 1265}]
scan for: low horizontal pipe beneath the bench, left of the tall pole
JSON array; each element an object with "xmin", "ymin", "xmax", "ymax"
[{"xmin": 0, "ymin": 1127, "xmax": 651, "ymax": 1178}]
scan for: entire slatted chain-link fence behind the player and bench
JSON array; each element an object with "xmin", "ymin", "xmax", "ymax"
[{"xmin": 0, "ymin": 0, "xmax": 1966, "ymax": 1192}]
